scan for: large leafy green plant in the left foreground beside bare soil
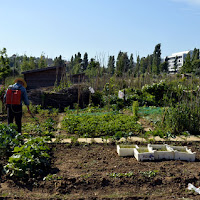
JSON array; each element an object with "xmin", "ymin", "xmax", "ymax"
[{"xmin": 4, "ymin": 137, "xmax": 50, "ymax": 178}]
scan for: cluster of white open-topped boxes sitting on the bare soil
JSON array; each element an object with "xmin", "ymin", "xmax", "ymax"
[{"xmin": 117, "ymin": 144, "xmax": 196, "ymax": 162}]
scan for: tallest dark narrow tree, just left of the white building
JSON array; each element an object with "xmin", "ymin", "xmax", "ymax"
[{"xmin": 152, "ymin": 44, "xmax": 161, "ymax": 74}]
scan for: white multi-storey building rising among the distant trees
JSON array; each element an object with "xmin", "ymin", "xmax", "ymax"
[{"xmin": 168, "ymin": 51, "xmax": 193, "ymax": 73}]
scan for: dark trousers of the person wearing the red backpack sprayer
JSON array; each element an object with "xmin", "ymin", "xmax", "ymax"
[{"xmin": 7, "ymin": 105, "xmax": 22, "ymax": 133}]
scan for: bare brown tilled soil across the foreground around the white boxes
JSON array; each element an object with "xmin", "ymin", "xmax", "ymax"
[{"xmin": 0, "ymin": 142, "xmax": 200, "ymax": 200}]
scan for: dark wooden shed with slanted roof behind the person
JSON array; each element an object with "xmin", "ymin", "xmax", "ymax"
[{"xmin": 22, "ymin": 66, "xmax": 66, "ymax": 89}]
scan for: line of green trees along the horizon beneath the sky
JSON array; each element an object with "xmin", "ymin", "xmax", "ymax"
[{"xmin": 0, "ymin": 44, "xmax": 200, "ymax": 83}]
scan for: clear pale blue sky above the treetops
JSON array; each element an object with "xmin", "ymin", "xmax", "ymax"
[{"xmin": 0, "ymin": 0, "xmax": 200, "ymax": 65}]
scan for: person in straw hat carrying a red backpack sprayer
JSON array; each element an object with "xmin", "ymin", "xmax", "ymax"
[{"xmin": 4, "ymin": 78, "xmax": 31, "ymax": 133}]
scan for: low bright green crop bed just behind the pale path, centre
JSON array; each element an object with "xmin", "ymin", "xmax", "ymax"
[{"xmin": 62, "ymin": 112, "xmax": 143, "ymax": 137}]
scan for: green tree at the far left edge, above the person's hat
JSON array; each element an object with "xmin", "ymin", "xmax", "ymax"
[{"xmin": 0, "ymin": 48, "xmax": 11, "ymax": 84}]
